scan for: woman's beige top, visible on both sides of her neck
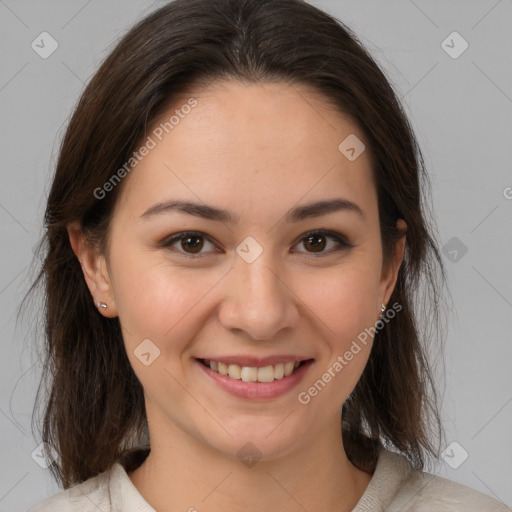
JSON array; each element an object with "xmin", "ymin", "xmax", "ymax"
[{"xmin": 27, "ymin": 450, "xmax": 512, "ymax": 512}]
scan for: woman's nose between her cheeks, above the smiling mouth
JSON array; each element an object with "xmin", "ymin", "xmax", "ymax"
[{"xmin": 218, "ymin": 251, "xmax": 300, "ymax": 341}]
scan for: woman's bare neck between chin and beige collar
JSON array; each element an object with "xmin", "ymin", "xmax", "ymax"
[{"xmin": 129, "ymin": 414, "xmax": 371, "ymax": 512}]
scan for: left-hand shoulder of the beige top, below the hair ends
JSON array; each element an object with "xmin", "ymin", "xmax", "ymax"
[{"xmin": 26, "ymin": 471, "xmax": 111, "ymax": 512}]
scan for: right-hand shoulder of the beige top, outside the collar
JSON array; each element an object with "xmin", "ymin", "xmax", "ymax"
[{"xmin": 386, "ymin": 452, "xmax": 512, "ymax": 512}]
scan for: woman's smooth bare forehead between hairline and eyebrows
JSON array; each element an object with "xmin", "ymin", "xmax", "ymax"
[{"xmin": 113, "ymin": 81, "xmax": 376, "ymax": 222}]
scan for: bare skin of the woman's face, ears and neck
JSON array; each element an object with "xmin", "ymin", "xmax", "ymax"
[{"xmin": 68, "ymin": 81, "xmax": 406, "ymax": 512}]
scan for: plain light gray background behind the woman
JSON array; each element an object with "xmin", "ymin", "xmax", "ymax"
[{"xmin": 0, "ymin": 0, "xmax": 512, "ymax": 512}]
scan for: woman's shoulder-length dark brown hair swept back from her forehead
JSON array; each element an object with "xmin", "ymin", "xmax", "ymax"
[{"xmin": 23, "ymin": 0, "xmax": 446, "ymax": 488}]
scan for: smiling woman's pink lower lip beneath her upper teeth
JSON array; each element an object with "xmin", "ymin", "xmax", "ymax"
[{"xmin": 196, "ymin": 359, "xmax": 313, "ymax": 400}]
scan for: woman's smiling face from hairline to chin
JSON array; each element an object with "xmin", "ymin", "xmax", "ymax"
[{"xmin": 69, "ymin": 82, "xmax": 404, "ymax": 459}]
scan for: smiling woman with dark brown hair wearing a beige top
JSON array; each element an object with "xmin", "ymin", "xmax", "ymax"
[{"xmin": 25, "ymin": 0, "xmax": 508, "ymax": 512}]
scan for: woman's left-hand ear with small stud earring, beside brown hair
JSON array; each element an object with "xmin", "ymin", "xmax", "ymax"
[{"xmin": 67, "ymin": 221, "xmax": 117, "ymax": 318}]
